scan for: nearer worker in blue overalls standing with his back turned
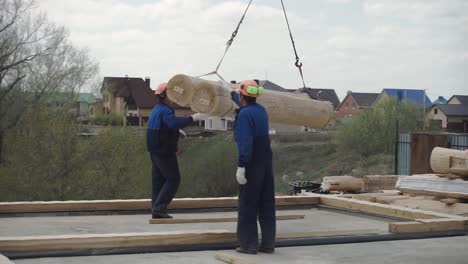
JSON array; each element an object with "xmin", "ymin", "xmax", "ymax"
[{"xmin": 231, "ymin": 80, "xmax": 276, "ymax": 254}]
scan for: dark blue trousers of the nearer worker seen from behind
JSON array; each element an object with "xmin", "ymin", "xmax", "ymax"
[{"xmin": 237, "ymin": 158, "xmax": 276, "ymax": 251}]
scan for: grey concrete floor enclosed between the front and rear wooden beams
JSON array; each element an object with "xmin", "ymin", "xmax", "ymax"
[{"xmin": 0, "ymin": 208, "xmax": 395, "ymax": 236}]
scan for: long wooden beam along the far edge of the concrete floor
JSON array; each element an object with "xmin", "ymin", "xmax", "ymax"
[{"xmin": 0, "ymin": 196, "xmax": 319, "ymax": 213}]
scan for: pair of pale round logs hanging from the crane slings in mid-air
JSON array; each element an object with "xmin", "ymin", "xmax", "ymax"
[{"xmin": 167, "ymin": 74, "xmax": 335, "ymax": 128}]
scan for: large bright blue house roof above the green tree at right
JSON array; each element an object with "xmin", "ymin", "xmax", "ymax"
[{"xmin": 374, "ymin": 88, "xmax": 432, "ymax": 108}]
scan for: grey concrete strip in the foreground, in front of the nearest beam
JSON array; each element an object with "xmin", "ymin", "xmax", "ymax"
[{"xmin": 13, "ymin": 236, "xmax": 468, "ymax": 264}]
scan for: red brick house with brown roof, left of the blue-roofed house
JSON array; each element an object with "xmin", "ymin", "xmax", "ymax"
[{"xmin": 336, "ymin": 91, "xmax": 379, "ymax": 119}]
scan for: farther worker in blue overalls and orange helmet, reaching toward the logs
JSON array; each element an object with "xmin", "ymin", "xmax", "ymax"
[{"xmin": 146, "ymin": 83, "xmax": 201, "ymax": 218}]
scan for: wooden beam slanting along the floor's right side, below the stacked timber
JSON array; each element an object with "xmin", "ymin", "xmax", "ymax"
[{"xmin": 317, "ymin": 194, "xmax": 459, "ymax": 220}]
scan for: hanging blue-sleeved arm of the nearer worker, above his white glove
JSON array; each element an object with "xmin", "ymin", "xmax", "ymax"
[{"xmin": 236, "ymin": 112, "xmax": 254, "ymax": 167}]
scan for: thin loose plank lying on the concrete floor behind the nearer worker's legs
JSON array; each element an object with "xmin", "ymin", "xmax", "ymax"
[{"xmin": 149, "ymin": 214, "xmax": 305, "ymax": 224}]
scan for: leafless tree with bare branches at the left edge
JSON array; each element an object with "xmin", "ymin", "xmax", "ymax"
[{"xmin": 0, "ymin": 0, "xmax": 98, "ymax": 162}]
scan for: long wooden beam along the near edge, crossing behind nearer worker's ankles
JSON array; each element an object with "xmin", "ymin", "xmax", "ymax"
[{"xmin": 0, "ymin": 229, "xmax": 378, "ymax": 253}]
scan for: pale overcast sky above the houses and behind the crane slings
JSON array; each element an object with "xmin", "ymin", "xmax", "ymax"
[{"xmin": 38, "ymin": 0, "xmax": 468, "ymax": 100}]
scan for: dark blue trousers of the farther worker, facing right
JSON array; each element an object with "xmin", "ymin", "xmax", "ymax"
[{"xmin": 150, "ymin": 153, "xmax": 180, "ymax": 212}]
